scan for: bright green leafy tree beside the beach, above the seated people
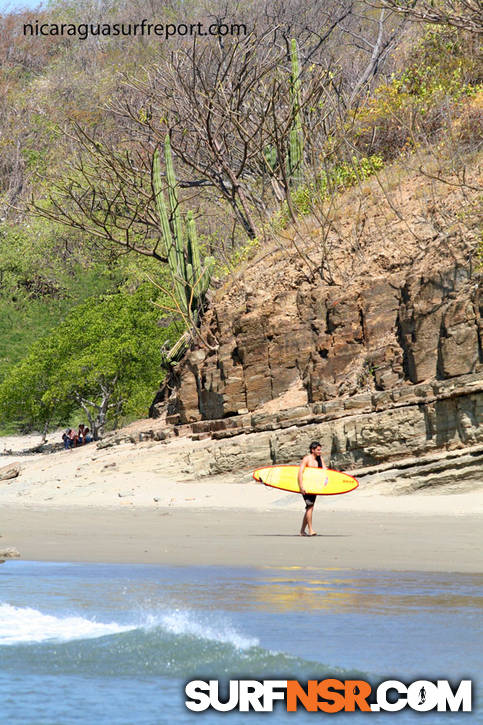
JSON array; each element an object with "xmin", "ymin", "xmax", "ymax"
[{"xmin": 0, "ymin": 285, "xmax": 179, "ymax": 436}]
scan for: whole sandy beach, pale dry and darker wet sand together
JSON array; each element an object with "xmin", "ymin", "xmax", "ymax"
[{"xmin": 0, "ymin": 430, "xmax": 483, "ymax": 572}]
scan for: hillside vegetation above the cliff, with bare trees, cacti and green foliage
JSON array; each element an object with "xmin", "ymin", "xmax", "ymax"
[{"xmin": 0, "ymin": 0, "xmax": 483, "ymax": 432}]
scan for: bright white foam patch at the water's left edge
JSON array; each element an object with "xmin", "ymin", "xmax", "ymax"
[{"xmin": 0, "ymin": 604, "xmax": 134, "ymax": 645}]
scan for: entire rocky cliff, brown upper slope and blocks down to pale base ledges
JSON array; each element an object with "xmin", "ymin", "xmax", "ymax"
[{"xmin": 151, "ymin": 165, "xmax": 483, "ymax": 485}]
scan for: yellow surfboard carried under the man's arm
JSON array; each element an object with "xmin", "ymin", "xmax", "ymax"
[{"xmin": 253, "ymin": 466, "xmax": 359, "ymax": 496}]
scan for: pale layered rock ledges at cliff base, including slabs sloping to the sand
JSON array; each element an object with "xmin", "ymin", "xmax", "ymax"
[{"xmin": 104, "ymin": 374, "xmax": 483, "ymax": 486}]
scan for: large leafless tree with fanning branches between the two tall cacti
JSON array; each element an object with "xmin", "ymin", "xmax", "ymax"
[{"xmin": 117, "ymin": 33, "xmax": 326, "ymax": 238}]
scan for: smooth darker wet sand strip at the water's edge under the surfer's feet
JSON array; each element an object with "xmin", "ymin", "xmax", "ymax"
[{"xmin": 0, "ymin": 506, "xmax": 482, "ymax": 572}]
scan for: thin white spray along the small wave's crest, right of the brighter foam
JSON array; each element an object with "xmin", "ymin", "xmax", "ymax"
[{"xmin": 147, "ymin": 610, "xmax": 259, "ymax": 650}]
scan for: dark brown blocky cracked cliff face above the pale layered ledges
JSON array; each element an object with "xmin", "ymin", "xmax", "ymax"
[{"xmin": 151, "ymin": 263, "xmax": 483, "ymax": 423}]
